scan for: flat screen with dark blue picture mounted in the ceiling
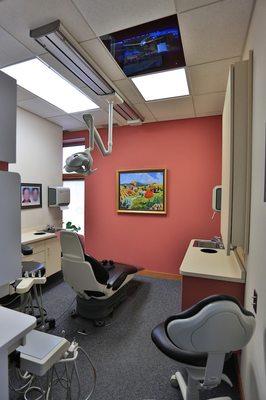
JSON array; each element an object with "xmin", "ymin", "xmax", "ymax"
[{"xmin": 101, "ymin": 15, "xmax": 186, "ymax": 76}]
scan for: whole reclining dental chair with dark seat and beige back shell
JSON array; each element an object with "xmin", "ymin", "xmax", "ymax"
[{"xmin": 60, "ymin": 231, "xmax": 138, "ymax": 326}]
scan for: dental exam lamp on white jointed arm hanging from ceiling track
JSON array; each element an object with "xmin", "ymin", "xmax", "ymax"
[{"xmin": 65, "ymin": 93, "xmax": 123, "ymax": 175}]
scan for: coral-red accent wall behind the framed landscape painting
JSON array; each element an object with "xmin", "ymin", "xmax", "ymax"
[{"xmin": 63, "ymin": 116, "xmax": 222, "ymax": 273}]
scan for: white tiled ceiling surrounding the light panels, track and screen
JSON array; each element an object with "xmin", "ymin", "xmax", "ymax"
[{"xmin": 0, "ymin": 0, "xmax": 254, "ymax": 130}]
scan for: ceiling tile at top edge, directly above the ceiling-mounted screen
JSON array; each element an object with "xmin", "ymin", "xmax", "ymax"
[{"xmin": 73, "ymin": 0, "xmax": 176, "ymax": 36}]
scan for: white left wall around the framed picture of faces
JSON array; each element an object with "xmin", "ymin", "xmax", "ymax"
[{"xmin": 9, "ymin": 108, "xmax": 62, "ymax": 231}]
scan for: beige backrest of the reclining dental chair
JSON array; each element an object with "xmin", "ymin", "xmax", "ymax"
[{"xmin": 60, "ymin": 231, "xmax": 106, "ymax": 297}]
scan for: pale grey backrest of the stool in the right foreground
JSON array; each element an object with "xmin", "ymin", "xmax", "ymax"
[{"xmin": 166, "ymin": 296, "xmax": 255, "ymax": 353}]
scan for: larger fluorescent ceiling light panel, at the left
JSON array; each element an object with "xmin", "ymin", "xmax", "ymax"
[{"xmin": 2, "ymin": 58, "xmax": 99, "ymax": 114}]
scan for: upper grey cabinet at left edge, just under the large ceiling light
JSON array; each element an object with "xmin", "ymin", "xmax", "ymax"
[{"xmin": 0, "ymin": 71, "xmax": 17, "ymax": 163}]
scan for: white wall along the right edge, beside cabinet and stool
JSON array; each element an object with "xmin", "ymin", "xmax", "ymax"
[{"xmin": 241, "ymin": 0, "xmax": 266, "ymax": 400}]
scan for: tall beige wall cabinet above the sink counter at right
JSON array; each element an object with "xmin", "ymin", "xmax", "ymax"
[{"xmin": 221, "ymin": 54, "xmax": 252, "ymax": 254}]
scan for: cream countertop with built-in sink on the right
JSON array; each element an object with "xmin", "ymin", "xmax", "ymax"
[{"xmin": 180, "ymin": 239, "xmax": 246, "ymax": 283}]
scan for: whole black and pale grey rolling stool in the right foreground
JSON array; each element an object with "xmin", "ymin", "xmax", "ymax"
[{"xmin": 152, "ymin": 295, "xmax": 255, "ymax": 400}]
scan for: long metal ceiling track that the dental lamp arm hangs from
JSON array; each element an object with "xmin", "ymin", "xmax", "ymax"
[{"xmin": 30, "ymin": 20, "xmax": 144, "ymax": 121}]
